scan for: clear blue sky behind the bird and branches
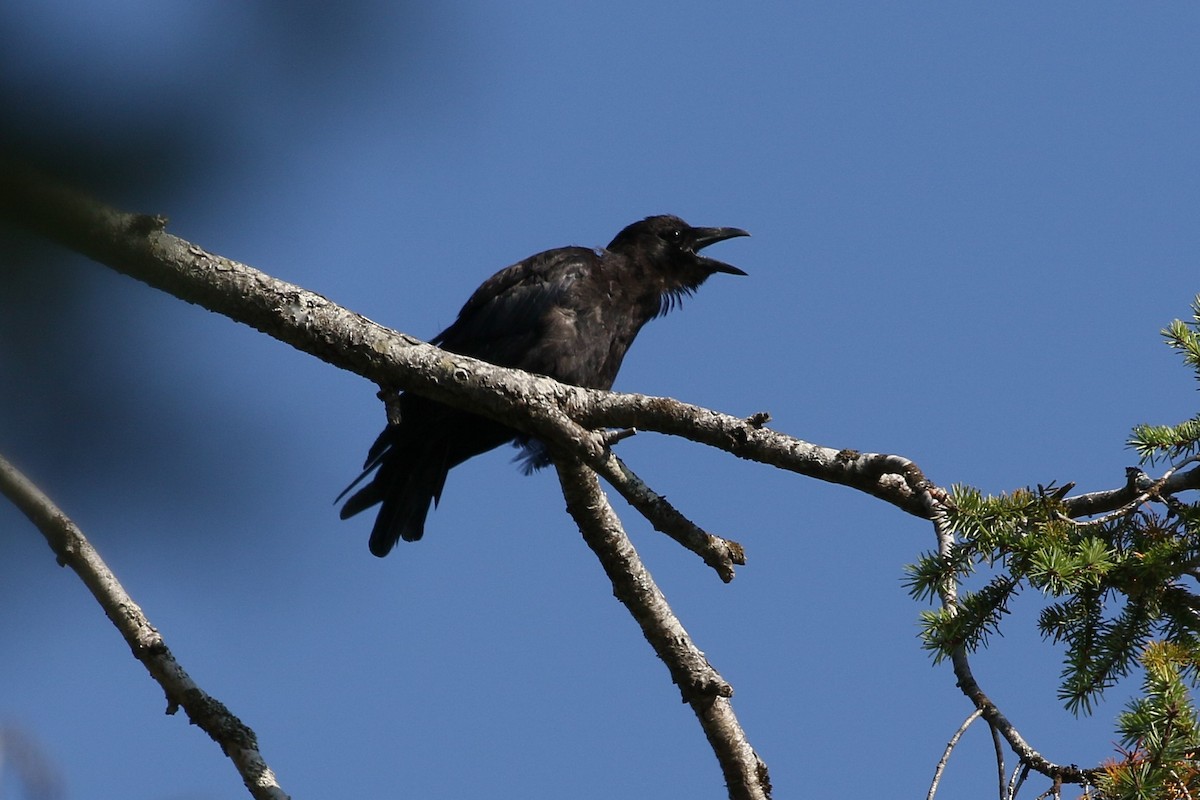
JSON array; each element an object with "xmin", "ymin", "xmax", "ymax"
[{"xmin": 0, "ymin": 2, "xmax": 1200, "ymax": 800}]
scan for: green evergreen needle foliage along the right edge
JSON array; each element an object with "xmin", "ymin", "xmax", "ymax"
[{"xmin": 907, "ymin": 297, "xmax": 1200, "ymax": 799}]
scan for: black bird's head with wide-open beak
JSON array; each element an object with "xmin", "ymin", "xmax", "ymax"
[{"xmin": 608, "ymin": 215, "xmax": 750, "ymax": 314}]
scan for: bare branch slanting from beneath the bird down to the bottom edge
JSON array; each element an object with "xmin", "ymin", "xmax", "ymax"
[{"xmin": 554, "ymin": 457, "xmax": 770, "ymax": 800}]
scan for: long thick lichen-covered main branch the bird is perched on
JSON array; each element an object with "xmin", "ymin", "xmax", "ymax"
[{"xmin": 0, "ymin": 163, "xmax": 937, "ymax": 518}]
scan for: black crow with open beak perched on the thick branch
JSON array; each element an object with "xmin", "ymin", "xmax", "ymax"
[{"xmin": 337, "ymin": 216, "xmax": 750, "ymax": 557}]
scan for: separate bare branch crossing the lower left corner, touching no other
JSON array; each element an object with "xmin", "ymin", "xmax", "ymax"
[{"xmin": 0, "ymin": 457, "xmax": 288, "ymax": 800}]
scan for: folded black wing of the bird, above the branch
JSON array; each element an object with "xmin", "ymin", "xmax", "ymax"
[{"xmin": 433, "ymin": 247, "xmax": 600, "ymax": 372}]
